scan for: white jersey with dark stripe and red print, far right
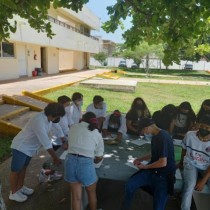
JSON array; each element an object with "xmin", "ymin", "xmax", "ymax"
[{"xmin": 182, "ymin": 131, "xmax": 210, "ymax": 170}]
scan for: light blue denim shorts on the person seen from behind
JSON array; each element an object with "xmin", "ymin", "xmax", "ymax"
[{"xmin": 64, "ymin": 154, "xmax": 98, "ymax": 187}]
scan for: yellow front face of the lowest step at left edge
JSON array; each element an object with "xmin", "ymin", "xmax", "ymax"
[{"xmin": 0, "ymin": 120, "xmax": 21, "ymax": 136}]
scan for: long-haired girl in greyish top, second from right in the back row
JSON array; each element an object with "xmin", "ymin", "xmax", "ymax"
[{"xmin": 173, "ymin": 101, "xmax": 196, "ymax": 139}]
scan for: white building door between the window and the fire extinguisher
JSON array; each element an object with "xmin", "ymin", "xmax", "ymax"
[{"xmin": 17, "ymin": 44, "xmax": 27, "ymax": 76}]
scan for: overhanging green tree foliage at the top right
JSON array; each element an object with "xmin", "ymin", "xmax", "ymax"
[{"xmin": 103, "ymin": 0, "xmax": 210, "ymax": 66}]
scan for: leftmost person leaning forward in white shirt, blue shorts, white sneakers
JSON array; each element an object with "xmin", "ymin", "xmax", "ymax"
[{"xmin": 9, "ymin": 103, "xmax": 65, "ymax": 202}]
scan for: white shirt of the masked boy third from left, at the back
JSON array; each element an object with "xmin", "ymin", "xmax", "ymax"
[{"xmin": 65, "ymin": 102, "xmax": 82, "ymax": 126}]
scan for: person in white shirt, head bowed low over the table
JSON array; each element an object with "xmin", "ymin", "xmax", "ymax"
[{"xmin": 102, "ymin": 110, "xmax": 127, "ymax": 142}]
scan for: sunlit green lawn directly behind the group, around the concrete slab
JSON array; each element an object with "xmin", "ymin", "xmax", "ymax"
[{"xmin": 45, "ymin": 83, "xmax": 210, "ymax": 113}]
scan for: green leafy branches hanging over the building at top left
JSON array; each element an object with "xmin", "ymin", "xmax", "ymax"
[{"xmin": 0, "ymin": 0, "xmax": 88, "ymax": 41}]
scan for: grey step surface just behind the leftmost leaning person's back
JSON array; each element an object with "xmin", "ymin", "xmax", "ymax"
[{"xmin": 5, "ymin": 111, "xmax": 38, "ymax": 128}]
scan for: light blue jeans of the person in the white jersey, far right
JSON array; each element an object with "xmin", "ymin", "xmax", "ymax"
[{"xmin": 181, "ymin": 162, "xmax": 210, "ymax": 210}]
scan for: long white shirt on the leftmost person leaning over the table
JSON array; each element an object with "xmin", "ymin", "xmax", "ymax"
[{"xmin": 11, "ymin": 112, "xmax": 52, "ymax": 157}]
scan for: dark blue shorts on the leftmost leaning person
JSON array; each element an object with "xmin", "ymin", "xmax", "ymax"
[{"xmin": 11, "ymin": 149, "xmax": 31, "ymax": 172}]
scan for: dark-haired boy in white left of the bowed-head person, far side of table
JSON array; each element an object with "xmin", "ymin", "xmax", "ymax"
[{"xmin": 86, "ymin": 95, "xmax": 106, "ymax": 130}]
